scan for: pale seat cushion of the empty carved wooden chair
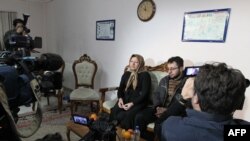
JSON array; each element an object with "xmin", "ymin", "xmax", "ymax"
[{"xmin": 70, "ymin": 87, "xmax": 100, "ymax": 100}]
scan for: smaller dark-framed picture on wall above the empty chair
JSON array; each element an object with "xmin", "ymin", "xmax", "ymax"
[{"xmin": 96, "ymin": 20, "xmax": 115, "ymax": 40}]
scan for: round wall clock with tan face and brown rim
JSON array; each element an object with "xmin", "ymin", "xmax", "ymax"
[{"xmin": 137, "ymin": 0, "xmax": 156, "ymax": 21}]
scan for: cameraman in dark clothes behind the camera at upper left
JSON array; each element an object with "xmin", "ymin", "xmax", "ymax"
[{"xmin": 3, "ymin": 19, "xmax": 24, "ymax": 51}]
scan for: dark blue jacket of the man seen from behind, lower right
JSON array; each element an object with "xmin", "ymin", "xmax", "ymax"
[{"xmin": 161, "ymin": 109, "xmax": 250, "ymax": 141}]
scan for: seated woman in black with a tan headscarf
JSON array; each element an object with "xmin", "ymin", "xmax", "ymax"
[{"xmin": 110, "ymin": 54, "xmax": 151, "ymax": 129}]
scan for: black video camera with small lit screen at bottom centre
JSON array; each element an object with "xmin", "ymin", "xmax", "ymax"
[{"xmin": 72, "ymin": 114, "xmax": 117, "ymax": 141}]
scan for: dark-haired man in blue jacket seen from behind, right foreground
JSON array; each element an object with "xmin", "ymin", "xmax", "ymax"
[{"xmin": 161, "ymin": 63, "xmax": 250, "ymax": 141}]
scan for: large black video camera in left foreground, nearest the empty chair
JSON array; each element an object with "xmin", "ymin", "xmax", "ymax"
[{"xmin": 0, "ymin": 53, "xmax": 64, "ymax": 119}]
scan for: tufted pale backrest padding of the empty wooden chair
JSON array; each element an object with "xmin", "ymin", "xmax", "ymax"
[{"xmin": 75, "ymin": 61, "xmax": 95, "ymax": 85}]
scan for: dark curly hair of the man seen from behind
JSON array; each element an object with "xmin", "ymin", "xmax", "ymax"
[{"xmin": 194, "ymin": 63, "xmax": 246, "ymax": 115}]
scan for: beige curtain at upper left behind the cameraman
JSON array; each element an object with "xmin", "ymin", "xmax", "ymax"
[{"xmin": 0, "ymin": 11, "xmax": 17, "ymax": 50}]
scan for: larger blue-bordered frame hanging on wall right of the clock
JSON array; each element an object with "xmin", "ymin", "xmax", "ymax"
[{"xmin": 182, "ymin": 8, "xmax": 231, "ymax": 43}]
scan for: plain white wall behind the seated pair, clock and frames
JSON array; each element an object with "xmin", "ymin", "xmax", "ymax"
[{"xmin": 0, "ymin": 0, "xmax": 250, "ymax": 121}]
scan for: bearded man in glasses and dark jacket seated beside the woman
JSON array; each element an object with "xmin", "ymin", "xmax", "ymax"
[{"xmin": 135, "ymin": 56, "xmax": 185, "ymax": 140}]
